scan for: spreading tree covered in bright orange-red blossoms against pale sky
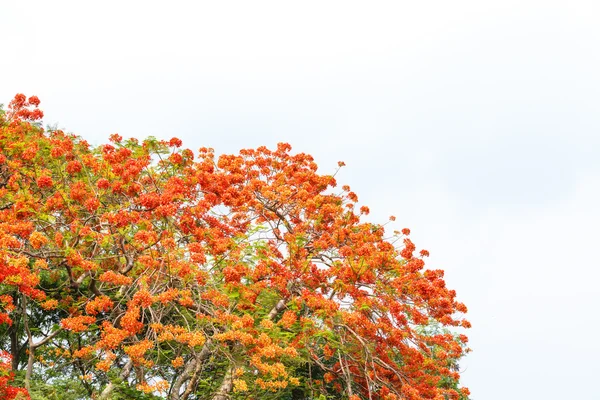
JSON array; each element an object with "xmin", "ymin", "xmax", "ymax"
[{"xmin": 0, "ymin": 95, "xmax": 469, "ymax": 400}]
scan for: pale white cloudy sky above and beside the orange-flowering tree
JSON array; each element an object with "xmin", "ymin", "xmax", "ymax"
[{"xmin": 0, "ymin": 0, "xmax": 600, "ymax": 400}]
